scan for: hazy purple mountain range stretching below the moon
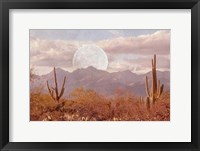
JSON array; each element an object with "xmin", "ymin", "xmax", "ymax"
[{"xmin": 31, "ymin": 66, "xmax": 170, "ymax": 97}]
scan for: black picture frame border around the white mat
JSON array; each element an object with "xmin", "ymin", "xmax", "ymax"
[{"xmin": 0, "ymin": 0, "xmax": 200, "ymax": 151}]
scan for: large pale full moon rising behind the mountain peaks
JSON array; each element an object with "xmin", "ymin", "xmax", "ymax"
[{"xmin": 73, "ymin": 45, "xmax": 108, "ymax": 70}]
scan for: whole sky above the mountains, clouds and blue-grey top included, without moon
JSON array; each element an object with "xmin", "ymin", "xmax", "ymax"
[{"xmin": 30, "ymin": 29, "xmax": 170, "ymax": 75}]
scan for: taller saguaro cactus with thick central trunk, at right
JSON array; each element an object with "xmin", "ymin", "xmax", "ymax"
[{"xmin": 146, "ymin": 54, "xmax": 164, "ymax": 108}]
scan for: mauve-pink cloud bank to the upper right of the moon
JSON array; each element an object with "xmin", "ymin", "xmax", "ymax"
[{"xmin": 97, "ymin": 30, "xmax": 170, "ymax": 55}]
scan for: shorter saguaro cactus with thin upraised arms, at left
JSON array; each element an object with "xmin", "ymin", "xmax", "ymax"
[{"xmin": 47, "ymin": 67, "xmax": 66, "ymax": 103}]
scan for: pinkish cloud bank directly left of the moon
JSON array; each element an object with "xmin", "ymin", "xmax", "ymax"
[{"xmin": 30, "ymin": 37, "xmax": 79, "ymax": 68}]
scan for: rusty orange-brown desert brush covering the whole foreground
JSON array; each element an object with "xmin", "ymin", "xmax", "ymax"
[{"xmin": 30, "ymin": 88, "xmax": 170, "ymax": 121}]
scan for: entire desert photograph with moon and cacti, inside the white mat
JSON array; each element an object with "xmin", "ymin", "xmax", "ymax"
[{"xmin": 29, "ymin": 29, "xmax": 171, "ymax": 121}]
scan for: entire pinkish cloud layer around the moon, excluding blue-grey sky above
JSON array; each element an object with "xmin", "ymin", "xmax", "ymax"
[{"xmin": 30, "ymin": 30, "xmax": 170, "ymax": 73}]
